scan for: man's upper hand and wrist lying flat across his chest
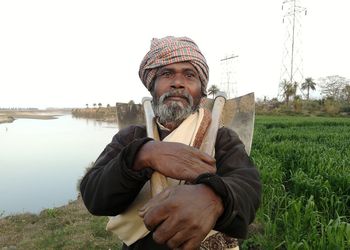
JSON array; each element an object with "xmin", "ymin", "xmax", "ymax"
[{"xmin": 133, "ymin": 141, "xmax": 216, "ymax": 182}]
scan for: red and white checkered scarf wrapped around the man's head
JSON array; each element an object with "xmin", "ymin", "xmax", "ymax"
[{"xmin": 139, "ymin": 36, "xmax": 209, "ymax": 96}]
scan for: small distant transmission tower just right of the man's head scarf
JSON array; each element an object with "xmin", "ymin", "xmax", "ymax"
[{"xmin": 220, "ymin": 54, "xmax": 238, "ymax": 98}]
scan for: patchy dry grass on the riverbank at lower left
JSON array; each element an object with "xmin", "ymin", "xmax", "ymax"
[{"xmin": 0, "ymin": 199, "xmax": 121, "ymax": 250}]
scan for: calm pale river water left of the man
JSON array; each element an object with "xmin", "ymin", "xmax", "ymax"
[{"xmin": 0, "ymin": 115, "xmax": 118, "ymax": 216}]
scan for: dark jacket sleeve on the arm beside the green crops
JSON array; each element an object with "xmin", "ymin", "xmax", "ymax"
[{"xmin": 196, "ymin": 128, "xmax": 261, "ymax": 238}]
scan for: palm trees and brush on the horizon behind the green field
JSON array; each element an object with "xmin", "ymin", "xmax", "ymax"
[{"xmin": 208, "ymin": 75, "xmax": 350, "ymax": 115}]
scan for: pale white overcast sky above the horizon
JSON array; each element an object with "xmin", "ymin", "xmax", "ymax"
[{"xmin": 0, "ymin": 0, "xmax": 350, "ymax": 108}]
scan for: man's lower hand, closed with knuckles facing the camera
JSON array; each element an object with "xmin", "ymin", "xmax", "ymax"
[{"xmin": 139, "ymin": 184, "xmax": 223, "ymax": 249}]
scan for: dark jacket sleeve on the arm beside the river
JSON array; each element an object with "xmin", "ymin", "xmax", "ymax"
[{"xmin": 80, "ymin": 126, "xmax": 152, "ymax": 216}]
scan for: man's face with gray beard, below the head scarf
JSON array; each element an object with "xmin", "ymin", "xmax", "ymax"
[{"xmin": 152, "ymin": 62, "xmax": 202, "ymax": 127}]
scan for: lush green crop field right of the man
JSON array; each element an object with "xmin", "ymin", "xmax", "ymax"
[{"xmin": 243, "ymin": 116, "xmax": 350, "ymax": 249}]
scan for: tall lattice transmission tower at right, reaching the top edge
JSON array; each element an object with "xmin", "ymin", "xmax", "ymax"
[{"xmin": 278, "ymin": 0, "xmax": 307, "ymax": 97}]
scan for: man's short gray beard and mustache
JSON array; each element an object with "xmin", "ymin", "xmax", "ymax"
[{"xmin": 152, "ymin": 90, "xmax": 199, "ymax": 127}]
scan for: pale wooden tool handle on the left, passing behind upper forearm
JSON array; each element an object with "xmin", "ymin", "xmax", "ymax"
[{"xmin": 142, "ymin": 97, "xmax": 169, "ymax": 197}]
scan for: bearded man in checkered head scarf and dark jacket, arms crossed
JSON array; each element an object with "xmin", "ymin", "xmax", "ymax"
[{"xmin": 80, "ymin": 37, "xmax": 261, "ymax": 249}]
